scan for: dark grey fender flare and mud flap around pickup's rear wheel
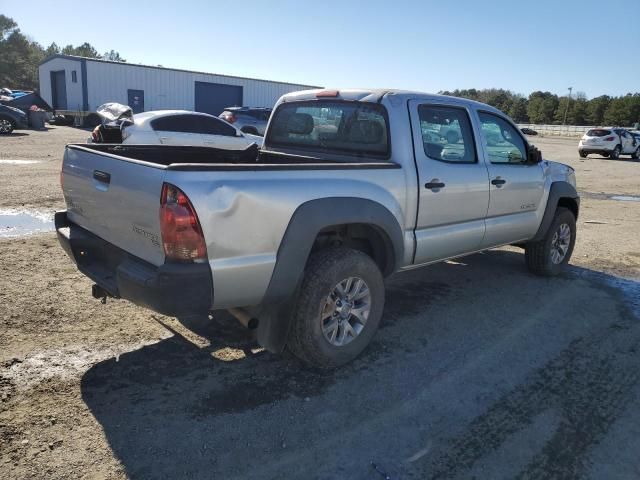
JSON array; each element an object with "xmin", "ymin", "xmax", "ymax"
[{"xmin": 256, "ymin": 197, "xmax": 404, "ymax": 352}]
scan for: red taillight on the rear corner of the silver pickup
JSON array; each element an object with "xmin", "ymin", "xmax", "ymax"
[{"xmin": 160, "ymin": 183, "xmax": 207, "ymax": 262}]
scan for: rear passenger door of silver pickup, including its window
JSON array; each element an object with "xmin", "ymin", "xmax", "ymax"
[{"xmin": 409, "ymin": 100, "xmax": 489, "ymax": 264}]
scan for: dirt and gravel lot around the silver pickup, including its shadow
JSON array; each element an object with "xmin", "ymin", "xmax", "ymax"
[{"xmin": 0, "ymin": 127, "xmax": 640, "ymax": 479}]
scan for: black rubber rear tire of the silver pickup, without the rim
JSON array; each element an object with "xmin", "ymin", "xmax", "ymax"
[{"xmin": 287, "ymin": 247, "xmax": 385, "ymax": 369}]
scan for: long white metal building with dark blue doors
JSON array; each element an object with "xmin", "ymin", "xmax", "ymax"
[{"xmin": 38, "ymin": 55, "xmax": 318, "ymax": 116}]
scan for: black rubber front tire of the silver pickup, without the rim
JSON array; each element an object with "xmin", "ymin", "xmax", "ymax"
[{"xmin": 524, "ymin": 207, "xmax": 576, "ymax": 276}]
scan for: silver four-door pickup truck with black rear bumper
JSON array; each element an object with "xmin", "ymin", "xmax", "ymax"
[{"xmin": 55, "ymin": 90, "xmax": 580, "ymax": 368}]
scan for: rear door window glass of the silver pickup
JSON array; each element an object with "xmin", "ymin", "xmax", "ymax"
[{"xmin": 418, "ymin": 105, "xmax": 478, "ymax": 163}]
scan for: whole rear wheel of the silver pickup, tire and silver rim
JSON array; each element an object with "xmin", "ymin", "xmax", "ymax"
[{"xmin": 287, "ymin": 247, "xmax": 384, "ymax": 368}]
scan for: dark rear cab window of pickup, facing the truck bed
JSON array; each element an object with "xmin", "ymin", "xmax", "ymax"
[{"xmin": 265, "ymin": 100, "xmax": 391, "ymax": 160}]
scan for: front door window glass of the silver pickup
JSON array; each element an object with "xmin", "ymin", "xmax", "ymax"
[{"xmin": 478, "ymin": 112, "xmax": 527, "ymax": 164}]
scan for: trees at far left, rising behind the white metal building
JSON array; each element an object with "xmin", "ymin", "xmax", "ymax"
[{"xmin": 0, "ymin": 14, "xmax": 126, "ymax": 90}]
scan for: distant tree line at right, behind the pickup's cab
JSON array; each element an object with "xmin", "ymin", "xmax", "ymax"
[{"xmin": 439, "ymin": 88, "xmax": 640, "ymax": 127}]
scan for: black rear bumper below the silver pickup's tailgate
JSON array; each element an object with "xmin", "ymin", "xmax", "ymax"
[{"xmin": 55, "ymin": 212, "xmax": 213, "ymax": 316}]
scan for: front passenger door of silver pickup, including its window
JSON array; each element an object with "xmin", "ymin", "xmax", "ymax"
[{"xmin": 478, "ymin": 111, "xmax": 544, "ymax": 248}]
